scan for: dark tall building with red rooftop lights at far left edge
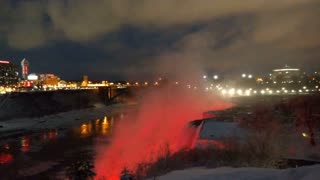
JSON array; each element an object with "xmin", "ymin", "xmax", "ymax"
[{"xmin": 0, "ymin": 60, "xmax": 19, "ymax": 86}]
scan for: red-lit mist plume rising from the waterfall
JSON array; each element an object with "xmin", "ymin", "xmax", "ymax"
[{"xmin": 95, "ymin": 88, "xmax": 231, "ymax": 180}]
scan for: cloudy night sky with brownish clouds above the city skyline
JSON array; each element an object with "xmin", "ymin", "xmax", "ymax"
[{"xmin": 0, "ymin": 0, "xmax": 320, "ymax": 80}]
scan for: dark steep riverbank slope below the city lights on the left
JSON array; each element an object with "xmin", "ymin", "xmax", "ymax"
[{"xmin": 0, "ymin": 90, "xmax": 101, "ymax": 122}]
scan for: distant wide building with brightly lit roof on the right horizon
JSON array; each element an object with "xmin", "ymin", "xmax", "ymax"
[{"xmin": 270, "ymin": 65, "xmax": 301, "ymax": 83}]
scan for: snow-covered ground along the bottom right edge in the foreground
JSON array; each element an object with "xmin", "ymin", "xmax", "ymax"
[{"xmin": 150, "ymin": 165, "xmax": 320, "ymax": 180}]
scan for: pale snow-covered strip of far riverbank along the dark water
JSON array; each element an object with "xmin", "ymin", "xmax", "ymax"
[{"xmin": 0, "ymin": 104, "xmax": 125, "ymax": 137}]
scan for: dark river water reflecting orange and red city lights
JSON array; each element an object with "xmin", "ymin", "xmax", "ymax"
[{"xmin": 0, "ymin": 116, "xmax": 119, "ymax": 180}]
